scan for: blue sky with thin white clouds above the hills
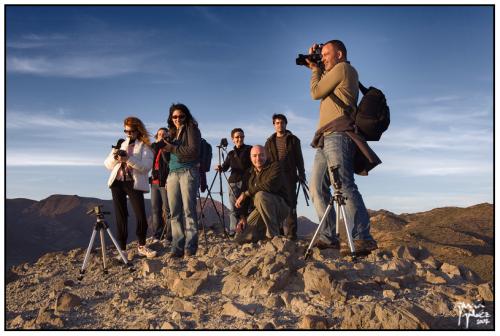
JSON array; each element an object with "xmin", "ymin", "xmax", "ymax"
[{"xmin": 5, "ymin": 6, "xmax": 494, "ymax": 220}]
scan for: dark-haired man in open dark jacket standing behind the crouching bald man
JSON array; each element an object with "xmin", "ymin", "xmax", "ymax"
[{"xmin": 265, "ymin": 114, "xmax": 306, "ymax": 240}]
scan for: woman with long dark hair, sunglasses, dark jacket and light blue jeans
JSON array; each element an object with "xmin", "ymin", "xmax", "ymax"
[{"xmin": 165, "ymin": 104, "xmax": 201, "ymax": 258}]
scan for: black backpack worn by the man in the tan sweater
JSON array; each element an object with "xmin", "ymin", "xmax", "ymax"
[{"xmin": 330, "ymin": 83, "xmax": 391, "ymax": 141}]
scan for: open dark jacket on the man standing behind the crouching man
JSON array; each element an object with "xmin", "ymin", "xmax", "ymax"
[{"xmin": 265, "ymin": 130, "xmax": 306, "ymax": 183}]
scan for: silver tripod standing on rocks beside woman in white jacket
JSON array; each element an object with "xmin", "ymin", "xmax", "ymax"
[{"xmin": 78, "ymin": 205, "xmax": 134, "ymax": 280}]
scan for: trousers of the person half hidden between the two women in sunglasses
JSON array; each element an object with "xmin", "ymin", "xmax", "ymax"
[{"xmin": 151, "ymin": 184, "xmax": 172, "ymax": 240}]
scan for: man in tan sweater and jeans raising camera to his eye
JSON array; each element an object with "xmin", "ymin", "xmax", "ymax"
[{"xmin": 306, "ymin": 40, "xmax": 377, "ymax": 254}]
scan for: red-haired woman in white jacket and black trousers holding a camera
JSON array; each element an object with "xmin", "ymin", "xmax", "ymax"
[{"xmin": 104, "ymin": 117, "xmax": 156, "ymax": 258}]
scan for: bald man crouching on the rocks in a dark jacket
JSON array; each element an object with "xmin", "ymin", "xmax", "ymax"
[{"xmin": 235, "ymin": 145, "xmax": 290, "ymax": 244}]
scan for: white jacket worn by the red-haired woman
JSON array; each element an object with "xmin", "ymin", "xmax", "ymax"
[{"xmin": 104, "ymin": 138, "xmax": 154, "ymax": 192}]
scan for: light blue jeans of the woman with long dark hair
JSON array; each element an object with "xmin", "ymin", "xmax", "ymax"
[{"xmin": 167, "ymin": 167, "xmax": 200, "ymax": 254}]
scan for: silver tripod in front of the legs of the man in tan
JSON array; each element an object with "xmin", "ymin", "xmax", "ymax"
[{"xmin": 304, "ymin": 166, "xmax": 356, "ymax": 259}]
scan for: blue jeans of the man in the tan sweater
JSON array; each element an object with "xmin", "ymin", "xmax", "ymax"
[{"xmin": 310, "ymin": 132, "xmax": 373, "ymax": 243}]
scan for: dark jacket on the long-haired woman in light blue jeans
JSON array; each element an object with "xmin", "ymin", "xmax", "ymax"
[{"xmin": 167, "ymin": 122, "xmax": 201, "ymax": 162}]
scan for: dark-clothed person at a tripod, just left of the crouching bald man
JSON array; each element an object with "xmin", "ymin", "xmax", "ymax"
[{"xmin": 215, "ymin": 128, "xmax": 252, "ymax": 237}]
